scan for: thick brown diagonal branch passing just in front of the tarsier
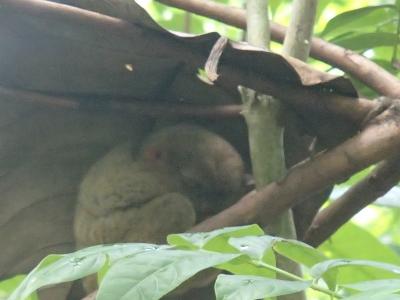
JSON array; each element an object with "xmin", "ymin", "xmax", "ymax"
[{"xmin": 192, "ymin": 103, "xmax": 400, "ymax": 231}]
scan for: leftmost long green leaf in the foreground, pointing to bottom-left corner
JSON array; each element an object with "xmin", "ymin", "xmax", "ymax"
[{"xmin": 9, "ymin": 244, "xmax": 159, "ymax": 300}]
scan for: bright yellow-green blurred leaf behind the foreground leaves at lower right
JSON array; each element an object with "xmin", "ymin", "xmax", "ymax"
[{"xmin": 318, "ymin": 223, "xmax": 400, "ymax": 284}]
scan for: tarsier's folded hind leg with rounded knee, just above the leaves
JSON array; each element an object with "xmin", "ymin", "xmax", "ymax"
[{"xmin": 75, "ymin": 193, "xmax": 195, "ymax": 292}]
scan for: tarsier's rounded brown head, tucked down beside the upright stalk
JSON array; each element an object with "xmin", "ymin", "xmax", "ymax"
[{"xmin": 139, "ymin": 125, "xmax": 245, "ymax": 220}]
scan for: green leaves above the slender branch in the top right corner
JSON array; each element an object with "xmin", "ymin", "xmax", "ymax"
[{"xmin": 321, "ymin": 0, "xmax": 400, "ymax": 97}]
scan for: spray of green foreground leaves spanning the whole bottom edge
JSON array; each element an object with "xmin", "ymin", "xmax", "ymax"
[{"xmin": 5, "ymin": 225, "xmax": 400, "ymax": 300}]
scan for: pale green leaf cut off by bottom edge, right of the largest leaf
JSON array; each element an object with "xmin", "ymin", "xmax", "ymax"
[{"xmin": 215, "ymin": 275, "xmax": 311, "ymax": 300}]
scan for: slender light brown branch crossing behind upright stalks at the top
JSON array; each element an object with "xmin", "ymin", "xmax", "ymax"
[{"xmin": 157, "ymin": 0, "xmax": 400, "ymax": 98}]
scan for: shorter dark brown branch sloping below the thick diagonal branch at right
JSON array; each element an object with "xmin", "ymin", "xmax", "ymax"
[{"xmin": 304, "ymin": 155, "xmax": 400, "ymax": 247}]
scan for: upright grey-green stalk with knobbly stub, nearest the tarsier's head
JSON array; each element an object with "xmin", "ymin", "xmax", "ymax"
[{"xmin": 239, "ymin": 0, "xmax": 304, "ymax": 300}]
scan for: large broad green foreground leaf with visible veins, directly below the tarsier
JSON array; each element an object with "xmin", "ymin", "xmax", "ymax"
[{"xmin": 97, "ymin": 249, "xmax": 239, "ymax": 300}]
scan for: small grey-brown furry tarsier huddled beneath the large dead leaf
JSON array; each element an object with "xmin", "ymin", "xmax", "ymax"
[{"xmin": 74, "ymin": 125, "xmax": 244, "ymax": 289}]
